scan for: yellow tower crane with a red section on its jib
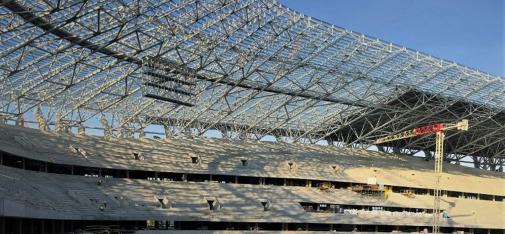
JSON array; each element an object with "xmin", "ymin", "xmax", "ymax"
[{"xmin": 373, "ymin": 119, "xmax": 468, "ymax": 234}]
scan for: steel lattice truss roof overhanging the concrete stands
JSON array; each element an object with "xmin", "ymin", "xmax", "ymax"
[{"xmin": 0, "ymin": 0, "xmax": 505, "ymax": 164}]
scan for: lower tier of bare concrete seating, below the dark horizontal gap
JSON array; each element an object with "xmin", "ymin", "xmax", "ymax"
[{"xmin": 0, "ymin": 166, "xmax": 505, "ymax": 228}]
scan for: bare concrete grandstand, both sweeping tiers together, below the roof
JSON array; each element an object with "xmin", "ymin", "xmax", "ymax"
[{"xmin": 0, "ymin": 125, "xmax": 505, "ymax": 232}]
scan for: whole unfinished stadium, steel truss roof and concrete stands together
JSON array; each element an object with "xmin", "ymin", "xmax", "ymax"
[{"xmin": 0, "ymin": 0, "xmax": 505, "ymax": 233}]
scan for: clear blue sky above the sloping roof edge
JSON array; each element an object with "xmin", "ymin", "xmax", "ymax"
[{"xmin": 280, "ymin": 0, "xmax": 505, "ymax": 77}]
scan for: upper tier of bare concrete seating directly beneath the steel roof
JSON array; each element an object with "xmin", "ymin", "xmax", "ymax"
[{"xmin": 0, "ymin": 125, "xmax": 505, "ymax": 196}]
